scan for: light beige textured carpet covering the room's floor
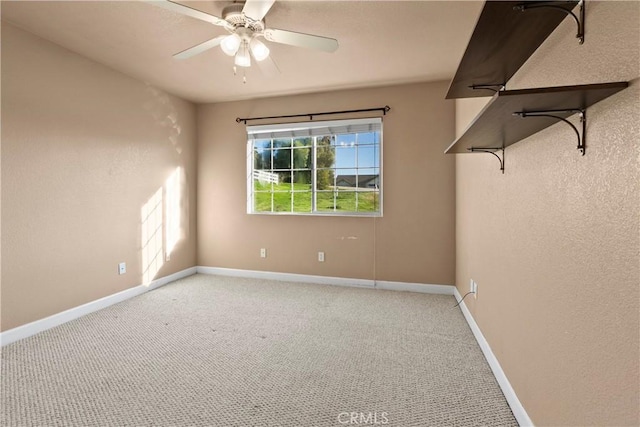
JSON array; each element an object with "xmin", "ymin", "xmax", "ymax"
[{"xmin": 0, "ymin": 274, "xmax": 518, "ymax": 427}]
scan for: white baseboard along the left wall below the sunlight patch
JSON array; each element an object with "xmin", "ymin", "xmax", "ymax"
[{"xmin": 0, "ymin": 267, "xmax": 196, "ymax": 346}]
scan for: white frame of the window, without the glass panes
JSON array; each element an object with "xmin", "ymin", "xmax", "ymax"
[{"xmin": 247, "ymin": 117, "xmax": 383, "ymax": 217}]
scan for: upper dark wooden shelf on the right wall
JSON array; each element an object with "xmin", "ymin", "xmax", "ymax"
[{"xmin": 447, "ymin": 1, "xmax": 579, "ymax": 99}]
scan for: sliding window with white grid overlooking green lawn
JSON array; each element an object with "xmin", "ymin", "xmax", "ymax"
[{"xmin": 247, "ymin": 118, "xmax": 382, "ymax": 216}]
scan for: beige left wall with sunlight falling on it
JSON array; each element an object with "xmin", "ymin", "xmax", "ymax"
[{"xmin": 1, "ymin": 22, "xmax": 196, "ymax": 330}]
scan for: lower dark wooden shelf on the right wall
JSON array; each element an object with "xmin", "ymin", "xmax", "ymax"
[{"xmin": 445, "ymin": 82, "xmax": 628, "ymax": 153}]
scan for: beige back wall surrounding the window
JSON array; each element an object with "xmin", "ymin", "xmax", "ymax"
[{"xmin": 198, "ymin": 82, "xmax": 455, "ymax": 284}]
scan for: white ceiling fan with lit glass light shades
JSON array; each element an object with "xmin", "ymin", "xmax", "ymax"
[{"xmin": 144, "ymin": 0, "xmax": 338, "ymax": 77}]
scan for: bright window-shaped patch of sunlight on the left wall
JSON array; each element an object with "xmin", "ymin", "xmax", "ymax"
[{"xmin": 140, "ymin": 167, "xmax": 186, "ymax": 286}]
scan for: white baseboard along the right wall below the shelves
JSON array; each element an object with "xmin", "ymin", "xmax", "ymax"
[{"xmin": 454, "ymin": 288, "xmax": 533, "ymax": 426}]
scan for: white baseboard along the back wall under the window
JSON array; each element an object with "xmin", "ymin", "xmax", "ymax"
[{"xmin": 197, "ymin": 266, "xmax": 455, "ymax": 295}]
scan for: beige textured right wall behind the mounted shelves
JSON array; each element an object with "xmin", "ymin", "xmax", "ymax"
[{"xmin": 456, "ymin": 2, "xmax": 640, "ymax": 426}]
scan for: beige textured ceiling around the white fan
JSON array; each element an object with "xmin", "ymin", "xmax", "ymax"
[{"xmin": 2, "ymin": 0, "xmax": 483, "ymax": 102}]
